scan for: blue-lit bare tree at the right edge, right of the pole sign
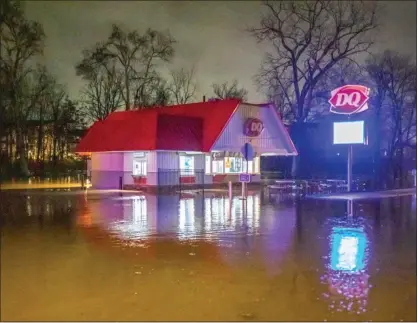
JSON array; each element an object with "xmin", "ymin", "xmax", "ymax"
[{"xmin": 367, "ymin": 51, "xmax": 417, "ymax": 186}]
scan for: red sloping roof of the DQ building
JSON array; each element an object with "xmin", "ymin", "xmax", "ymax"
[{"xmin": 76, "ymin": 100, "xmax": 239, "ymax": 153}]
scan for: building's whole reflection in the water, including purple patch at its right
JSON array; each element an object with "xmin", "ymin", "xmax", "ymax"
[{"xmin": 84, "ymin": 194, "xmax": 296, "ymax": 275}]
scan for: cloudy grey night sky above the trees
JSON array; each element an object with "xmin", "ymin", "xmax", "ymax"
[{"xmin": 25, "ymin": 1, "xmax": 417, "ymax": 102}]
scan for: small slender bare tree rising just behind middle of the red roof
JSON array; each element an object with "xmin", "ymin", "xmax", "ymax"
[{"xmin": 170, "ymin": 68, "xmax": 196, "ymax": 104}]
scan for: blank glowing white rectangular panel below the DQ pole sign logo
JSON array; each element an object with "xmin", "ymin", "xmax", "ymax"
[{"xmin": 334, "ymin": 121, "xmax": 365, "ymax": 145}]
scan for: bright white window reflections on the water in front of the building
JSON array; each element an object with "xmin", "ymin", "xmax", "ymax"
[{"xmin": 103, "ymin": 195, "xmax": 260, "ymax": 240}]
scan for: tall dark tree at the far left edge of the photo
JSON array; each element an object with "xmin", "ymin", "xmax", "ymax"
[{"xmin": 0, "ymin": 1, "xmax": 46, "ymax": 175}]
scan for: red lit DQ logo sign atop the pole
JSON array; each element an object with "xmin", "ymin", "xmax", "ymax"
[{"xmin": 328, "ymin": 85, "xmax": 370, "ymax": 114}]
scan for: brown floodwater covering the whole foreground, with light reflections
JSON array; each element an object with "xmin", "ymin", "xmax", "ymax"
[{"xmin": 0, "ymin": 190, "xmax": 417, "ymax": 321}]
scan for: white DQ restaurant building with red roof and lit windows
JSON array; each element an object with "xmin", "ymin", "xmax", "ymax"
[{"xmin": 76, "ymin": 100, "xmax": 297, "ymax": 189}]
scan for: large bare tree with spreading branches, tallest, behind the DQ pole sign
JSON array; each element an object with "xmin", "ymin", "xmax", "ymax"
[{"xmin": 250, "ymin": 0, "xmax": 378, "ymax": 176}]
